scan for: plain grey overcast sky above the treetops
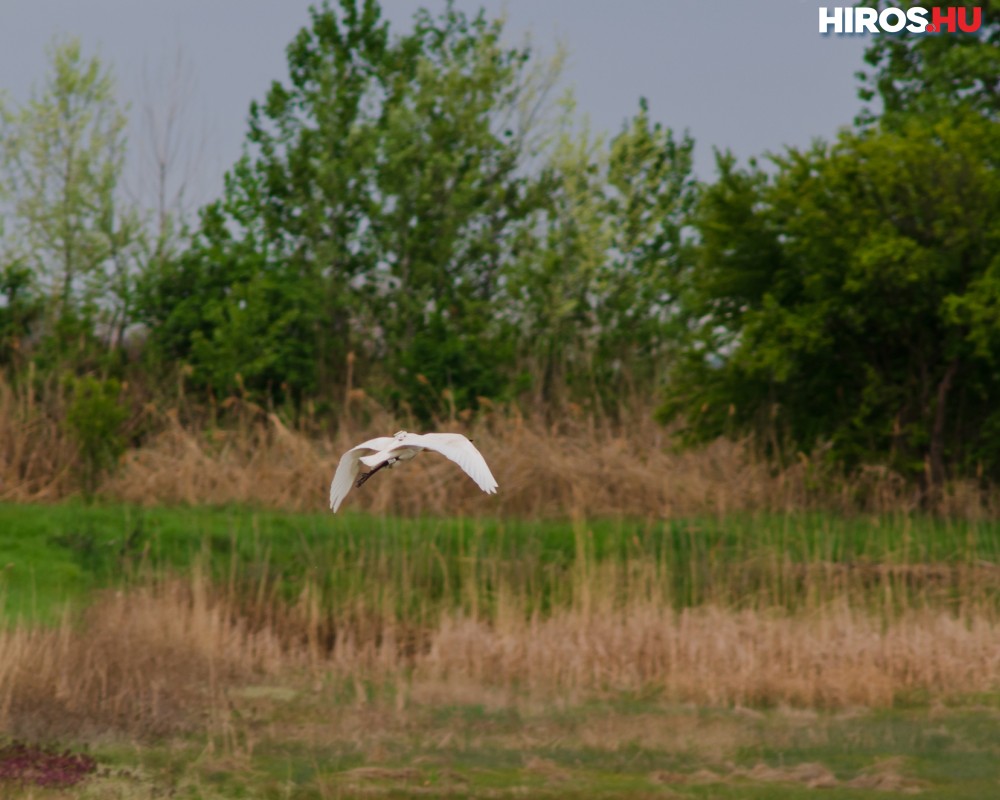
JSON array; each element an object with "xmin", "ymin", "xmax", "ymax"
[{"xmin": 0, "ymin": 0, "xmax": 869, "ymax": 209}]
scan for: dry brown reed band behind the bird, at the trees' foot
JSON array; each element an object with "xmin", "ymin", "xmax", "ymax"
[{"xmin": 0, "ymin": 380, "xmax": 1000, "ymax": 518}]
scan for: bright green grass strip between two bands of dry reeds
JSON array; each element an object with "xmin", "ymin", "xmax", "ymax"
[{"xmin": 0, "ymin": 504, "xmax": 1000, "ymax": 621}]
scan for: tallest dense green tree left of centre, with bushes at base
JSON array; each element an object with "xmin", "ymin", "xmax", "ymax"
[{"xmin": 144, "ymin": 0, "xmax": 556, "ymax": 413}]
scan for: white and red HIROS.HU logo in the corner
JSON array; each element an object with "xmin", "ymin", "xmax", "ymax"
[{"xmin": 819, "ymin": 6, "xmax": 983, "ymax": 33}]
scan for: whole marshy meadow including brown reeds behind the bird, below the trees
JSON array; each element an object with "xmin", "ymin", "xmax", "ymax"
[{"xmin": 0, "ymin": 376, "xmax": 1000, "ymax": 800}]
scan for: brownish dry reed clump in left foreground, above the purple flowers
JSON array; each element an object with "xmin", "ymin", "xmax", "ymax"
[{"xmin": 0, "ymin": 571, "xmax": 288, "ymax": 738}]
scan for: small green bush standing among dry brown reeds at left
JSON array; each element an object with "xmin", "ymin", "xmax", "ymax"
[{"xmin": 65, "ymin": 375, "xmax": 128, "ymax": 497}]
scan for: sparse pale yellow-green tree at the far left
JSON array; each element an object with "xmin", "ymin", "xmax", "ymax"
[{"xmin": 0, "ymin": 39, "xmax": 140, "ymax": 350}]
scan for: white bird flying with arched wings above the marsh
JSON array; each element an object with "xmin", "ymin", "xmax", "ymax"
[{"xmin": 330, "ymin": 431, "xmax": 497, "ymax": 513}]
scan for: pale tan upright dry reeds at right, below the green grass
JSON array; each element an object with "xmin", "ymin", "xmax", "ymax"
[{"xmin": 417, "ymin": 606, "xmax": 1000, "ymax": 708}]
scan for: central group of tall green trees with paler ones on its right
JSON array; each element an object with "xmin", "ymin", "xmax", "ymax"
[{"xmin": 127, "ymin": 0, "xmax": 694, "ymax": 422}]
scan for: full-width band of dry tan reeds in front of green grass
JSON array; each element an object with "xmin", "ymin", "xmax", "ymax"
[{"xmin": 0, "ymin": 571, "xmax": 1000, "ymax": 739}]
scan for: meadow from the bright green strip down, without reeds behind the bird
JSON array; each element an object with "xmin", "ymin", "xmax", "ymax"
[{"xmin": 0, "ymin": 504, "xmax": 1000, "ymax": 798}]
